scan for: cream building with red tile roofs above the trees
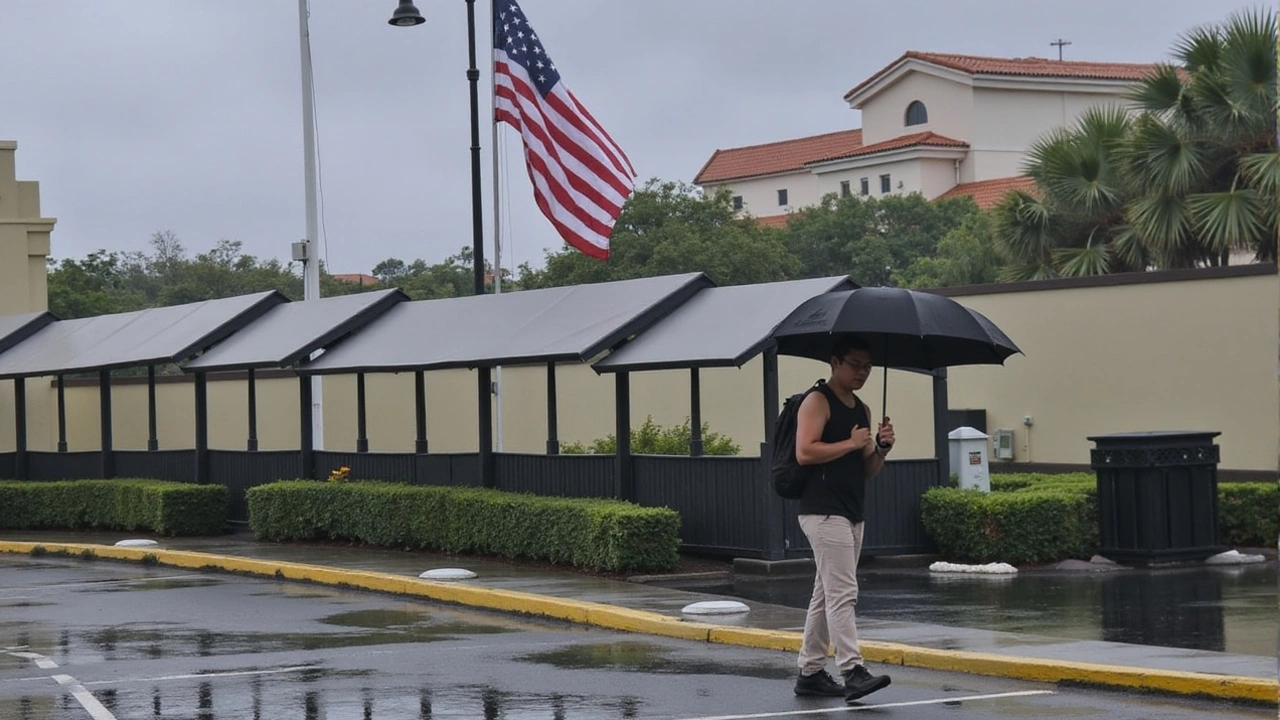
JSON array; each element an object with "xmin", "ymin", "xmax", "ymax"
[{"xmin": 694, "ymin": 51, "xmax": 1153, "ymax": 215}]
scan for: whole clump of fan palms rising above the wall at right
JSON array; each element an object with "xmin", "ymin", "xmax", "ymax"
[{"xmin": 995, "ymin": 12, "xmax": 1280, "ymax": 281}]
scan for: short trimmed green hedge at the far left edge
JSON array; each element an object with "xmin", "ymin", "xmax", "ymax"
[{"xmin": 0, "ymin": 479, "xmax": 227, "ymax": 536}]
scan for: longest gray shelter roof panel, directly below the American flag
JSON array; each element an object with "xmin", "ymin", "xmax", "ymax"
[{"xmin": 298, "ymin": 273, "xmax": 713, "ymax": 374}]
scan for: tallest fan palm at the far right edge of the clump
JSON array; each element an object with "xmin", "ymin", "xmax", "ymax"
[{"xmin": 1117, "ymin": 10, "xmax": 1280, "ymax": 266}]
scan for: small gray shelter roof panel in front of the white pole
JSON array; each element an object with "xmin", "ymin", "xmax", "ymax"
[{"xmin": 183, "ymin": 288, "xmax": 408, "ymax": 373}]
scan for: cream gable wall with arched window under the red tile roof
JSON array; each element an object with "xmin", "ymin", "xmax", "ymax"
[{"xmin": 861, "ymin": 72, "xmax": 974, "ymax": 145}]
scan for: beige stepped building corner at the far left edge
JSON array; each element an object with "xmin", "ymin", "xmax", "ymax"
[{"xmin": 0, "ymin": 141, "xmax": 55, "ymax": 315}]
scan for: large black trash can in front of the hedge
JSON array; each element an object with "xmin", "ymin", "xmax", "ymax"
[{"xmin": 1089, "ymin": 432, "xmax": 1226, "ymax": 565}]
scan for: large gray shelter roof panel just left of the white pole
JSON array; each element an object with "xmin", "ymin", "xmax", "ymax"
[{"xmin": 0, "ymin": 291, "xmax": 288, "ymax": 378}]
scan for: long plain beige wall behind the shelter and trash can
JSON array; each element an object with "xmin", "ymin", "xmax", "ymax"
[{"xmin": 17, "ymin": 263, "xmax": 1280, "ymax": 471}]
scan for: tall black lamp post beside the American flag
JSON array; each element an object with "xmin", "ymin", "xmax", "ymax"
[{"xmin": 387, "ymin": 0, "xmax": 493, "ymax": 487}]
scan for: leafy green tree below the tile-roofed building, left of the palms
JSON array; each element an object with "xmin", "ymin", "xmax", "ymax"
[{"xmin": 785, "ymin": 192, "xmax": 978, "ymax": 286}]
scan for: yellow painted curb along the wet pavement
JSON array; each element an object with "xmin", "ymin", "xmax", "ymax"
[{"xmin": 0, "ymin": 541, "xmax": 1280, "ymax": 703}]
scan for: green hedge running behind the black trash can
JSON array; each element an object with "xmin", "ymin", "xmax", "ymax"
[{"xmin": 920, "ymin": 473, "xmax": 1280, "ymax": 564}]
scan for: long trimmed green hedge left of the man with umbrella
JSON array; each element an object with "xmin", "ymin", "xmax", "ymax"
[{"xmin": 246, "ymin": 480, "xmax": 680, "ymax": 571}]
